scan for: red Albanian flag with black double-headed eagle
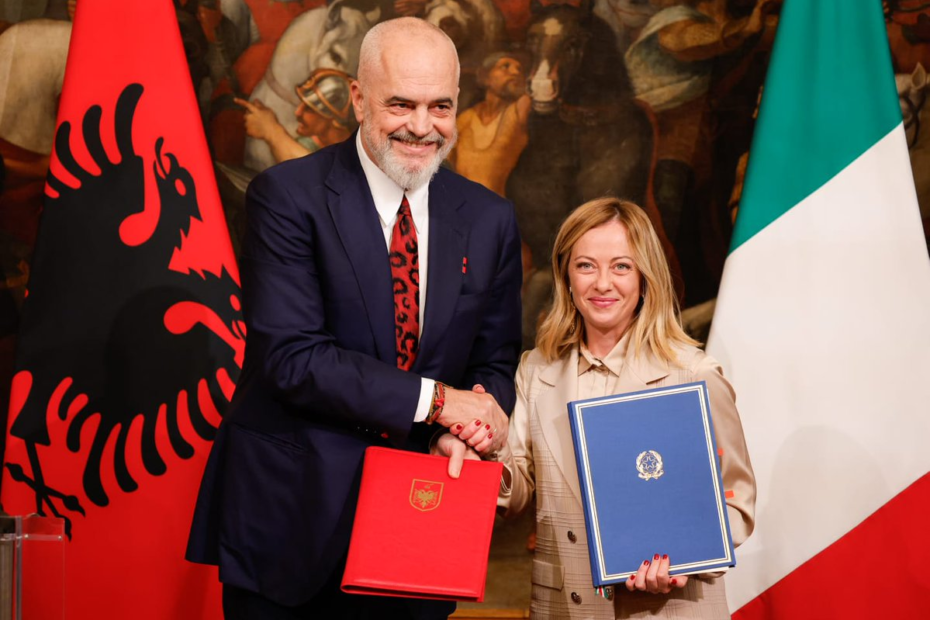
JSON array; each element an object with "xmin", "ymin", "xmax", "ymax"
[{"xmin": 2, "ymin": 0, "xmax": 245, "ymax": 620}]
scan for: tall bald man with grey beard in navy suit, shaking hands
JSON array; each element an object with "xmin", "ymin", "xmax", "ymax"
[{"xmin": 187, "ymin": 18, "xmax": 521, "ymax": 619}]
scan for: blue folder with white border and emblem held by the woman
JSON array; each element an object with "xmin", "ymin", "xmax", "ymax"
[{"xmin": 568, "ymin": 381, "xmax": 736, "ymax": 586}]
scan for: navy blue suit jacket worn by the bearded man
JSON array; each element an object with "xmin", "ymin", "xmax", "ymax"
[{"xmin": 187, "ymin": 137, "xmax": 522, "ymax": 605}]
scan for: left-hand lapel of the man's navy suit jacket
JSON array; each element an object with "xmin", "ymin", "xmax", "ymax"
[{"xmin": 326, "ymin": 140, "xmax": 397, "ymax": 364}]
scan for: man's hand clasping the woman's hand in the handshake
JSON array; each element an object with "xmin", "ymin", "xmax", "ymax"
[{"xmin": 437, "ymin": 385, "xmax": 509, "ymax": 454}]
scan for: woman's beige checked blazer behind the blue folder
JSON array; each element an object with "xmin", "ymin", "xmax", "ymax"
[{"xmin": 498, "ymin": 347, "xmax": 756, "ymax": 620}]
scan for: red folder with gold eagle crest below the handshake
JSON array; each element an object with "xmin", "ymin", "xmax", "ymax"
[{"xmin": 342, "ymin": 446, "xmax": 502, "ymax": 602}]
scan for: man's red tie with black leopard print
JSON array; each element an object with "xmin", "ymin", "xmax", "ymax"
[{"xmin": 390, "ymin": 196, "xmax": 420, "ymax": 370}]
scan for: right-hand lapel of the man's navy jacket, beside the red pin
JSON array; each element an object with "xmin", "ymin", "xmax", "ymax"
[{"xmin": 412, "ymin": 177, "xmax": 468, "ymax": 372}]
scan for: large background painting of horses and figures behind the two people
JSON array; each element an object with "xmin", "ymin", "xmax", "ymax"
[{"xmin": 0, "ymin": 0, "xmax": 930, "ymax": 604}]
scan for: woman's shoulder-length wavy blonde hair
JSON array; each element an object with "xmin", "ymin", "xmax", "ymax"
[{"xmin": 536, "ymin": 198, "xmax": 699, "ymax": 364}]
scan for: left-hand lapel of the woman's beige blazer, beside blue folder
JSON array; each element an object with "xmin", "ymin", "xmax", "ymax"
[{"xmin": 536, "ymin": 347, "xmax": 581, "ymax": 503}]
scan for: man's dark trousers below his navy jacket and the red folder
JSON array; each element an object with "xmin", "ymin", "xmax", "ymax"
[{"xmin": 223, "ymin": 564, "xmax": 455, "ymax": 620}]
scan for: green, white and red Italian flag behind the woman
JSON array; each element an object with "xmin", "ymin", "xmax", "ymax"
[{"xmin": 708, "ymin": 0, "xmax": 930, "ymax": 620}]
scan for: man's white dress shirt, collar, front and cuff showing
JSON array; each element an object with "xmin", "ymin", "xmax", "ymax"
[{"xmin": 355, "ymin": 130, "xmax": 436, "ymax": 422}]
